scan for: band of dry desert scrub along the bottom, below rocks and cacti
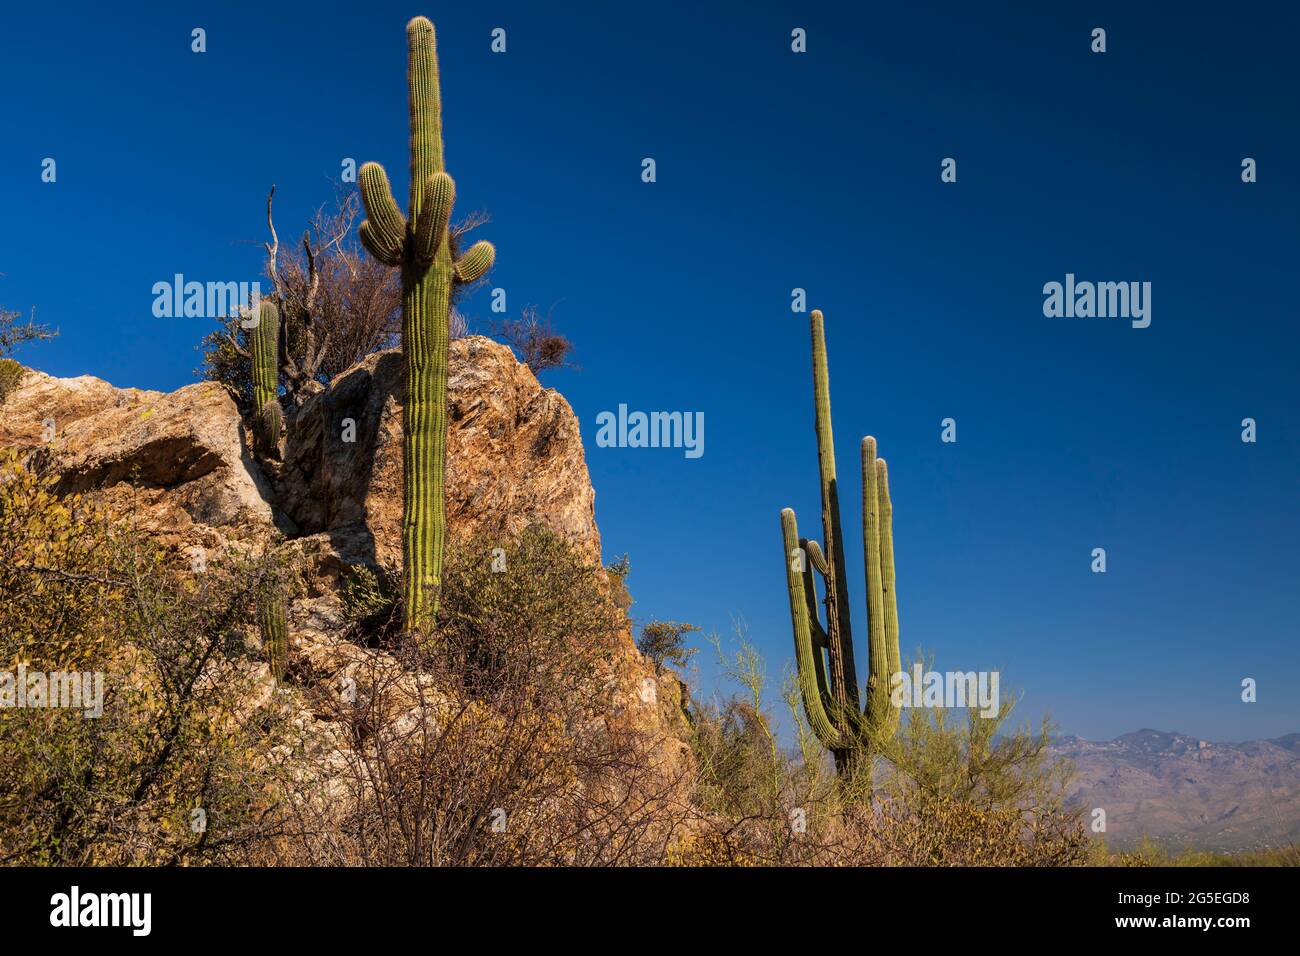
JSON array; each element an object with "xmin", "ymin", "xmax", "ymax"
[{"xmin": 0, "ymin": 447, "xmax": 1086, "ymax": 865}]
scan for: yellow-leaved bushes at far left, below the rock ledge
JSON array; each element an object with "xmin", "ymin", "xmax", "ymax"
[{"xmin": 0, "ymin": 455, "xmax": 306, "ymax": 865}]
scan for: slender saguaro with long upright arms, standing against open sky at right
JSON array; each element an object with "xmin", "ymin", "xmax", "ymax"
[{"xmin": 781, "ymin": 311, "xmax": 898, "ymax": 773}]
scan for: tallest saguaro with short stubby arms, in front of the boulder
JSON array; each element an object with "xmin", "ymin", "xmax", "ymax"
[{"xmin": 358, "ymin": 17, "xmax": 495, "ymax": 632}]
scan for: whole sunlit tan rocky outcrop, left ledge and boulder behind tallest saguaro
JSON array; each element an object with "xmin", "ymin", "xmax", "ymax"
[{"xmin": 0, "ymin": 337, "xmax": 689, "ymax": 790}]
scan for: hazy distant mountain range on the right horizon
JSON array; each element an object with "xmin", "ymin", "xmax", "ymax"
[{"xmin": 1052, "ymin": 730, "xmax": 1300, "ymax": 851}]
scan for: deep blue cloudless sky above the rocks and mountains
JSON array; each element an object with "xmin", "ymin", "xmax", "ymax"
[{"xmin": 0, "ymin": 0, "xmax": 1300, "ymax": 740}]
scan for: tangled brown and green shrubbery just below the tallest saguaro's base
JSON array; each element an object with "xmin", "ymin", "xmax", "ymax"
[{"xmin": 286, "ymin": 527, "xmax": 685, "ymax": 866}]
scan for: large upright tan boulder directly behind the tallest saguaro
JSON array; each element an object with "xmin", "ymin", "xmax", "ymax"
[{"xmin": 274, "ymin": 336, "xmax": 601, "ymax": 566}]
